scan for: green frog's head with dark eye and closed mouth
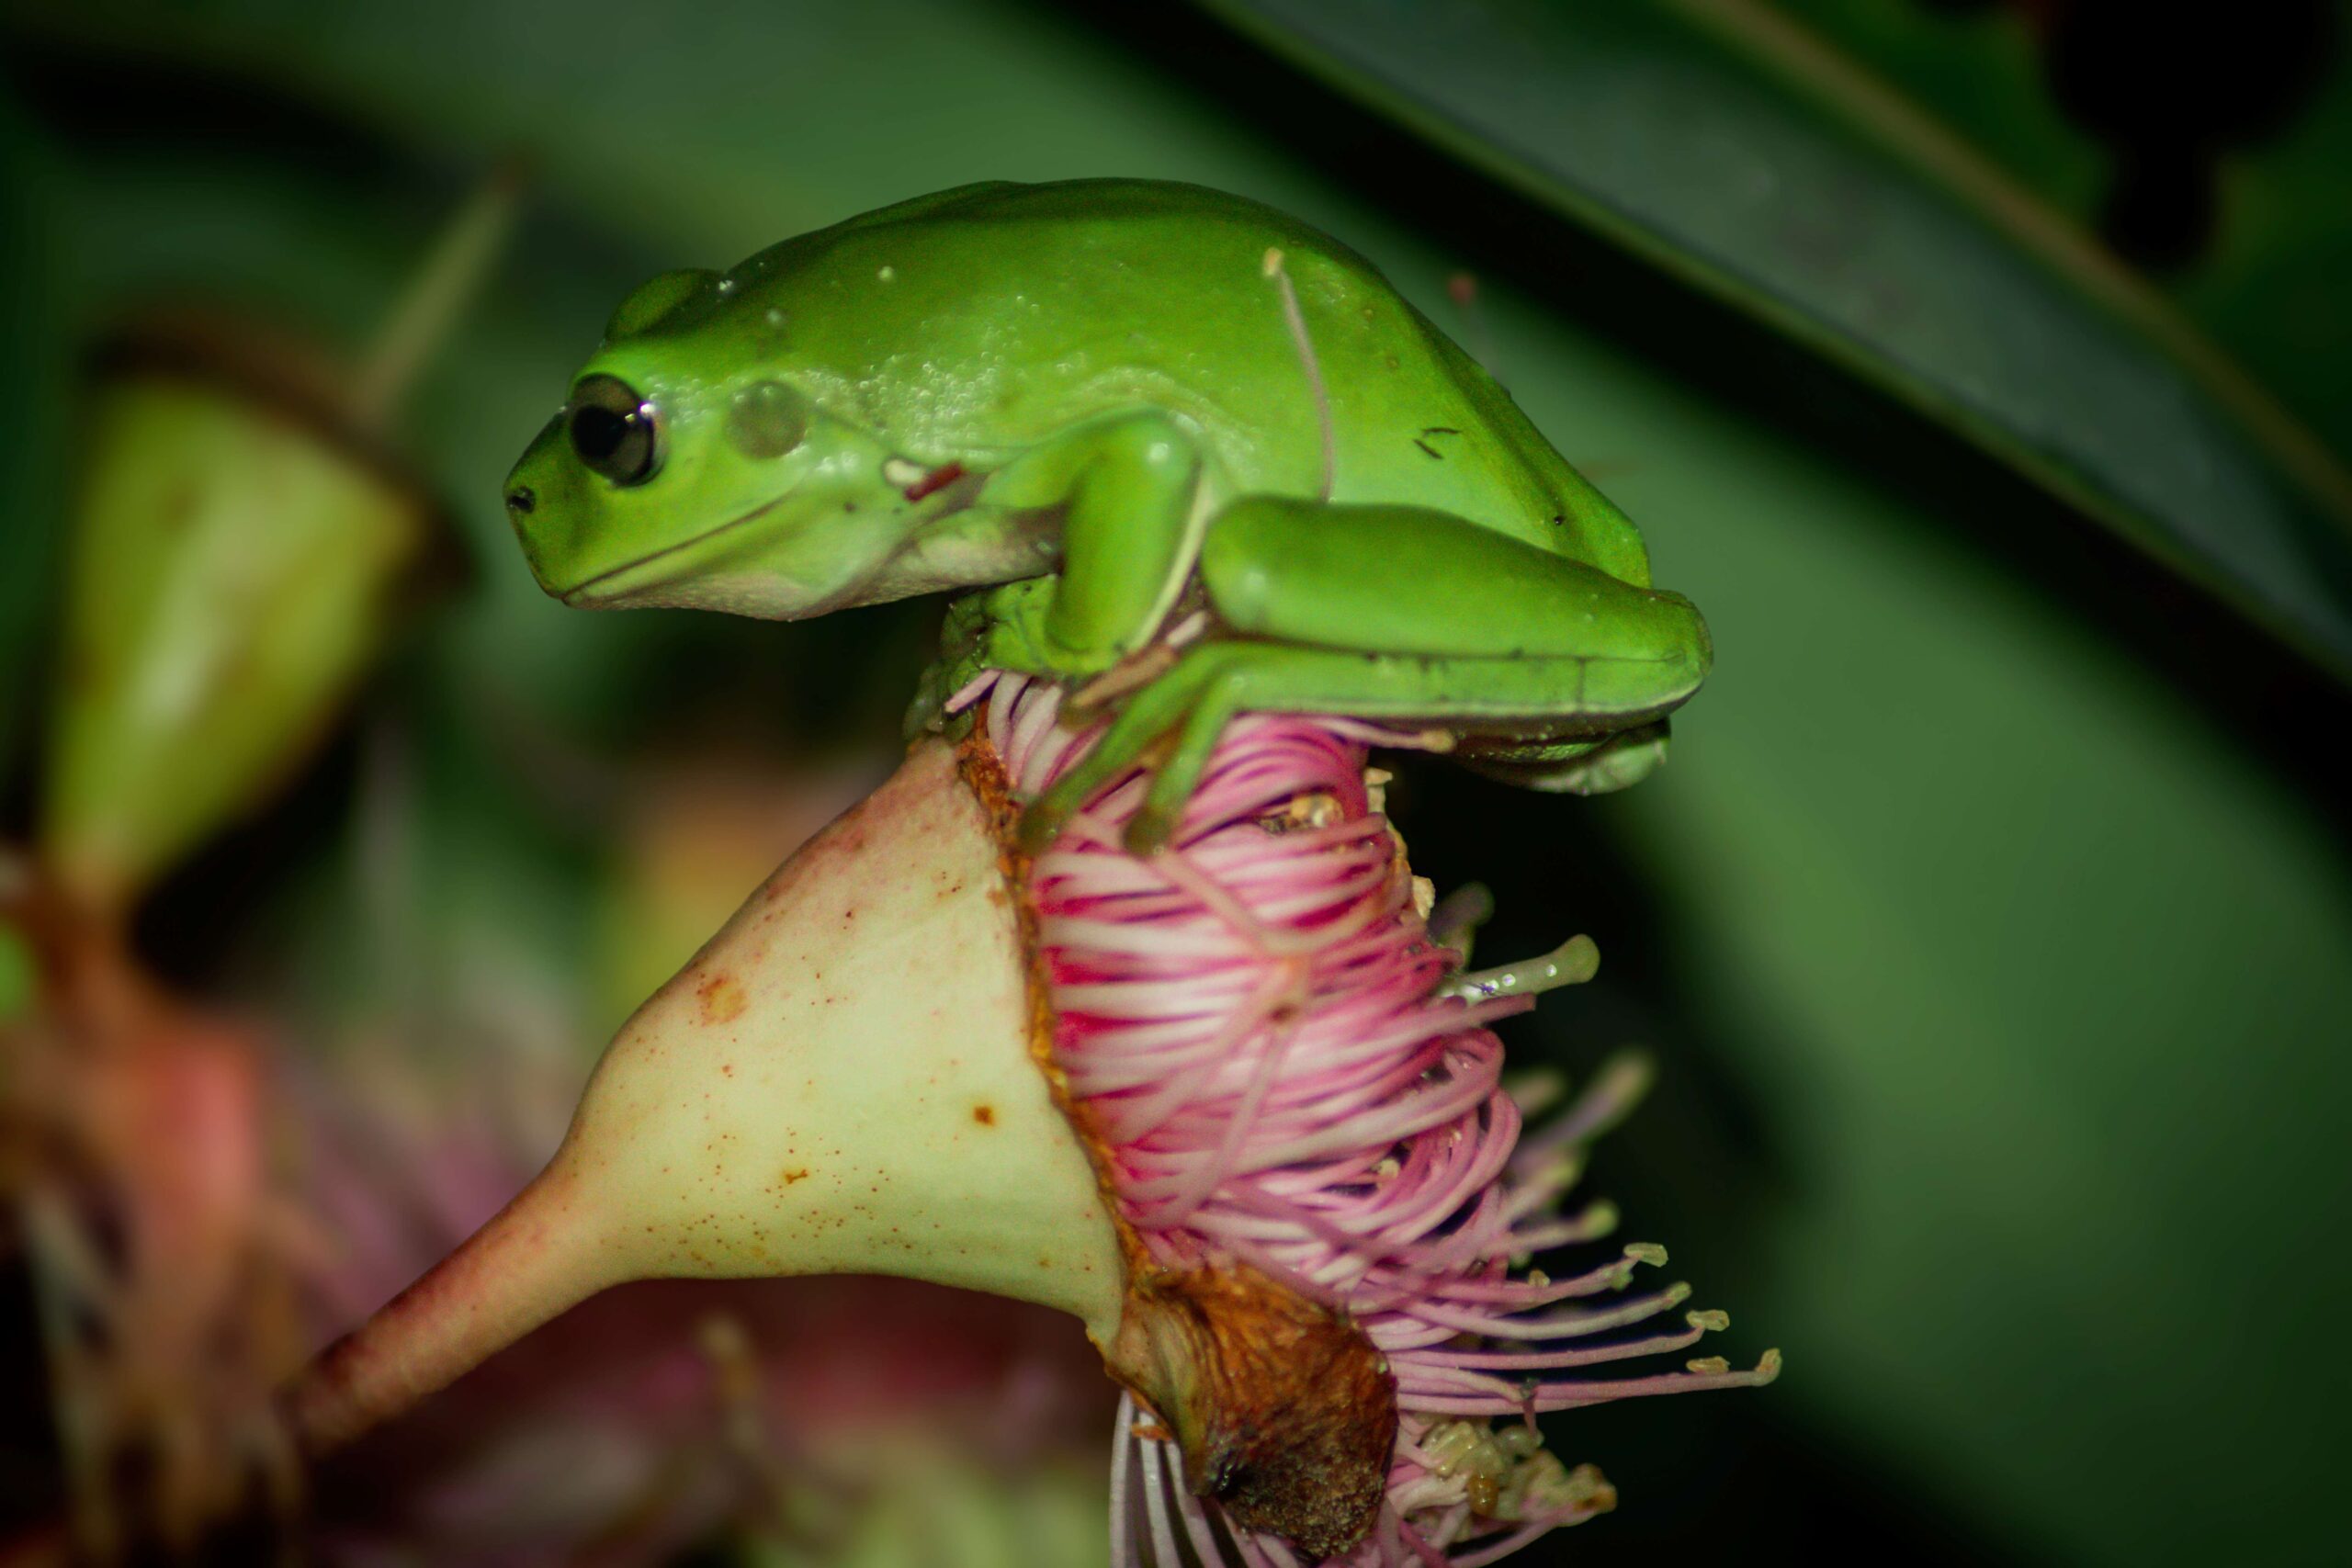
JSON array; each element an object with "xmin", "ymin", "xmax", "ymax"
[{"xmin": 505, "ymin": 273, "xmax": 920, "ymax": 621}]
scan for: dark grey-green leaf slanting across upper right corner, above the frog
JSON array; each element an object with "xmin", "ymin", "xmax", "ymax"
[{"xmin": 1206, "ymin": 0, "xmax": 2352, "ymax": 672}]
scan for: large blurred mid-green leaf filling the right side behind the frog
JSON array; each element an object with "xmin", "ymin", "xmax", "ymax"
[{"xmin": 1599, "ymin": 394, "xmax": 2352, "ymax": 1563}]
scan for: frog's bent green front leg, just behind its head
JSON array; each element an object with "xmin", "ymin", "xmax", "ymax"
[{"xmin": 978, "ymin": 409, "xmax": 1206, "ymax": 680}]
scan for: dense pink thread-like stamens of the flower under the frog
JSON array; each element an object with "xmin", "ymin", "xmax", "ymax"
[{"xmin": 959, "ymin": 674, "xmax": 1778, "ymax": 1568}]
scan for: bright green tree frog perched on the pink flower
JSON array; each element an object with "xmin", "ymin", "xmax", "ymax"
[{"xmin": 505, "ymin": 181, "xmax": 1710, "ymax": 853}]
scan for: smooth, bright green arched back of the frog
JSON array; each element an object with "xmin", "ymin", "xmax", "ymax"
[{"xmin": 729, "ymin": 179, "xmax": 1649, "ymax": 583}]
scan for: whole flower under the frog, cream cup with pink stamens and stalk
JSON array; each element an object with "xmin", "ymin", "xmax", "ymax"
[{"xmin": 291, "ymin": 674, "xmax": 1776, "ymax": 1568}]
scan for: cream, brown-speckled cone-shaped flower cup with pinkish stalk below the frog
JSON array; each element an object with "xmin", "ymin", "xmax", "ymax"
[{"xmin": 289, "ymin": 740, "xmax": 1126, "ymax": 1453}]
